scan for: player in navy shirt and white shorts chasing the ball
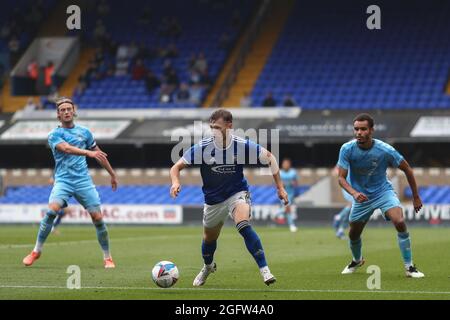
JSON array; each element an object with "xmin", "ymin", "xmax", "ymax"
[{"xmin": 170, "ymin": 109, "xmax": 288, "ymax": 287}]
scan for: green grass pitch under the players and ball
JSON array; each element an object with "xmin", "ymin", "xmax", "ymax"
[{"xmin": 0, "ymin": 225, "xmax": 450, "ymax": 300}]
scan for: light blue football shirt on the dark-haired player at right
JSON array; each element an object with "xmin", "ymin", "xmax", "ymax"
[{"xmin": 337, "ymin": 139, "xmax": 404, "ymax": 199}]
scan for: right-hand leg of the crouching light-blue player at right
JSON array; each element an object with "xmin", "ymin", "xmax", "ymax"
[{"xmin": 386, "ymin": 207, "xmax": 425, "ymax": 278}]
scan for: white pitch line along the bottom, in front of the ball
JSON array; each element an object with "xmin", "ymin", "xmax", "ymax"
[{"xmin": 0, "ymin": 285, "xmax": 450, "ymax": 295}]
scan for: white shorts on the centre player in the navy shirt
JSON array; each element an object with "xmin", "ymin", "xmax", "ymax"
[{"xmin": 203, "ymin": 191, "xmax": 252, "ymax": 228}]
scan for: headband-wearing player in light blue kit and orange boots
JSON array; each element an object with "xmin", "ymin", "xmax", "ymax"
[{"xmin": 23, "ymin": 98, "xmax": 117, "ymax": 268}]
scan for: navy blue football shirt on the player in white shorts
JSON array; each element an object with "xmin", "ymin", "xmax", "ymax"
[{"xmin": 182, "ymin": 136, "xmax": 262, "ymax": 205}]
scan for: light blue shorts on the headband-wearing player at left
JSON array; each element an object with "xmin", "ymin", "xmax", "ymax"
[{"xmin": 48, "ymin": 180, "xmax": 101, "ymax": 213}]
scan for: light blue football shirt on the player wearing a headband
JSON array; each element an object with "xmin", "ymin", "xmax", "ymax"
[{"xmin": 48, "ymin": 125, "xmax": 96, "ymax": 183}]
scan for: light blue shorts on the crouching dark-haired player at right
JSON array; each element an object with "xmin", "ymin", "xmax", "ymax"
[{"xmin": 349, "ymin": 190, "xmax": 402, "ymax": 222}]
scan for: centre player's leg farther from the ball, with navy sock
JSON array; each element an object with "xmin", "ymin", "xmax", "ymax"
[{"xmin": 234, "ymin": 203, "xmax": 276, "ymax": 285}]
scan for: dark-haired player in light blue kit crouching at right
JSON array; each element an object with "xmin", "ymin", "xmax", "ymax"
[{"xmin": 337, "ymin": 114, "xmax": 424, "ymax": 278}]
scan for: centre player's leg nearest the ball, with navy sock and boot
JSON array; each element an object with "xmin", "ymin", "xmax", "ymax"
[{"xmin": 192, "ymin": 223, "xmax": 223, "ymax": 287}]
